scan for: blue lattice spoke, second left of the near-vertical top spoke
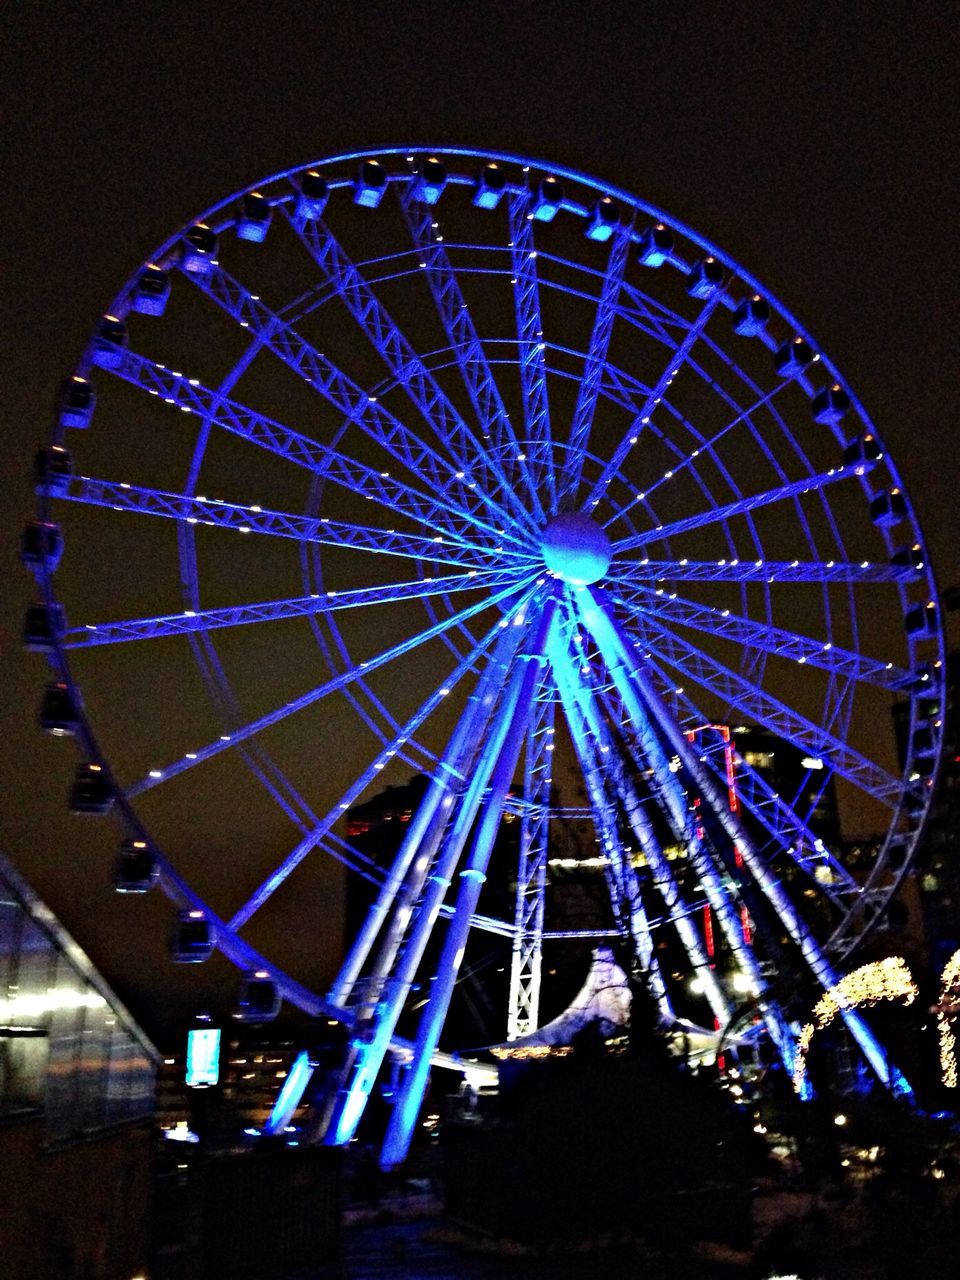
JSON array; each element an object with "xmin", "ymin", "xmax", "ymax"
[{"xmin": 284, "ymin": 206, "xmax": 534, "ymax": 531}]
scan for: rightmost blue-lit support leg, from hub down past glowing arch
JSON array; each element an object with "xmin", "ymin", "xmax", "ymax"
[{"xmin": 581, "ymin": 589, "xmax": 913, "ymax": 1093}]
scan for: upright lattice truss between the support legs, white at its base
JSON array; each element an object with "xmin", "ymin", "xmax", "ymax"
[{"xmin": 507, "ymin": 677, "xmax": 554, "ymax": 1039}]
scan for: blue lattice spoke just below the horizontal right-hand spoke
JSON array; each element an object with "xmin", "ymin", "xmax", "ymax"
[{"xmin": 611, "ymin": 584, "xmax": 910, "ymax": 689}]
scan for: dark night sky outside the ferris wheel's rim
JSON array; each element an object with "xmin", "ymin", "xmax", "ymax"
[{"xmin": 0, "ymin": 0, "xmax": 960, "ymax": 1039}]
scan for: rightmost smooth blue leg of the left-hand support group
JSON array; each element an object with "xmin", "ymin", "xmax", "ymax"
[{"xmin": 381, "ymin": 598, "xmax": 556, "ymax": 1169}]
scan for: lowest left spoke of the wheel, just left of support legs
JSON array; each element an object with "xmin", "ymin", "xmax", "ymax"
[{"xmin": 230, "ymin": 593, "xmax": 530, "ymax": 931}]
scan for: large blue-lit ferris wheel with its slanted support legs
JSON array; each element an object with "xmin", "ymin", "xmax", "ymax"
[{"xmin": 23, "ymin": 147, "xmax": 945, "ymax": 1162}]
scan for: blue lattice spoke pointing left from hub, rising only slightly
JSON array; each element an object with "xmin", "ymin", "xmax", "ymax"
[{"xmin": 59, "ymin": 476, "xmax": 527, "ymax": 572}]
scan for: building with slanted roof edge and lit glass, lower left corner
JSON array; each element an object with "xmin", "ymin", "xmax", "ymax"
[{"xmin": 0, "ymin": 856, "xmax": 159, "ymax": 1280}]
